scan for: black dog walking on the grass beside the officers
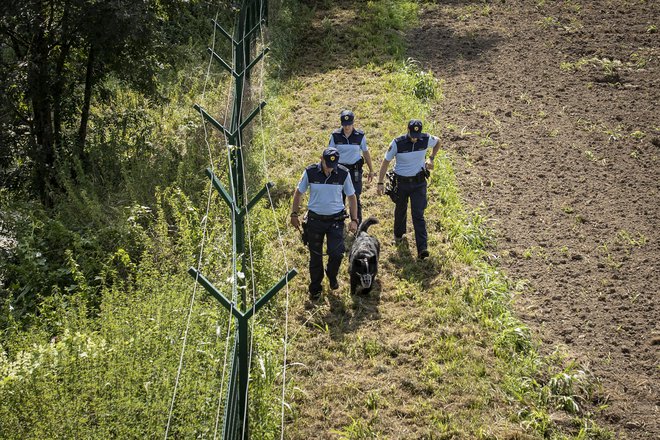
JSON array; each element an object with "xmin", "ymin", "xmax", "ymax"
[{"xmin": 348, "ymin": 217, "xmax": 380, "ymax": 295}]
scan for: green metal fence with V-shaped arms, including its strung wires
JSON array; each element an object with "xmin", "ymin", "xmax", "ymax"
[{"xmin": 177, "ymin": 0, "xmax": 297, "ymax": 440}]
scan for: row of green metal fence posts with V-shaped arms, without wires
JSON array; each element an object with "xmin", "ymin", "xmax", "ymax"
[{"xmin": 188, "ymin": 0, "xmax": 298, "ymax": 440}]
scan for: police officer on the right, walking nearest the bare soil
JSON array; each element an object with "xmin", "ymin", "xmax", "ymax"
[{"xmin": 377, "ymin": 119, "xmax": 440, "ymax": 260}]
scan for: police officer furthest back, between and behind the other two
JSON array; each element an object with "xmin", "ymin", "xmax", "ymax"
[{"xmin": 328, "ymin": 110, "xmax": 376, "ymax": 222}]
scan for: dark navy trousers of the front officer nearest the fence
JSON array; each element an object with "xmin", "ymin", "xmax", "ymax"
[{"xmin": 307, "ymin": 218, "xmax": 345, "ymax": 293}]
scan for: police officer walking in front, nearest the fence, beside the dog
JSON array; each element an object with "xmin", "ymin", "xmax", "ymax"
[{"xmin": 291, "ymin": 147, "xmax": 358, "ymax": 299}]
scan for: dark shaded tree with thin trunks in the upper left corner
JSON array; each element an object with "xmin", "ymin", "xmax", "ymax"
[{"xmin": 0, "ymin": 0, "xmax": 211, "ymax": 205}]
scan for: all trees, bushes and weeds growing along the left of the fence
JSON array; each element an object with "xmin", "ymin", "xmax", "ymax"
[{"xmin": 0, "ymin": 0, "xmax": 292, "ymax": 439}]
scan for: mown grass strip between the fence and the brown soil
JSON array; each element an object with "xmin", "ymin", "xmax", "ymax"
[{"xmin": 255, "ymin": 1, "xmax": 609, "ymax": 438}]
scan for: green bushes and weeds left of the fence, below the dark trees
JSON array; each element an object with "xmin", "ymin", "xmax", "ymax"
[{"xmin": 0, "ymin": 2, "xmax": 246, "ymax": 439}]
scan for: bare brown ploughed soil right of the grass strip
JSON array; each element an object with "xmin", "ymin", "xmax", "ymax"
[{"xmin": 416, "ymin": 0, "xmax": 660, "ymax": 439}]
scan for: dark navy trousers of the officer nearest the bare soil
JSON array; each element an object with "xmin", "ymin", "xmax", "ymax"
[{"xmin": 394, "ymin": 181, "xmax": 428, "ymax": 255}]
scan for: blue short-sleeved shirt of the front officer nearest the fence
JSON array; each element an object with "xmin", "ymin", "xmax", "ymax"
[{"xmin": 298, "ymin": 162, "xmax": 355, "ymax": 215}]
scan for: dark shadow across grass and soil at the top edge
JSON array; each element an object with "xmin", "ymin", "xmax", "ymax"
[{"xmin": 271, "ymin": 0, "xmax": 501, "ymax": 80}]
